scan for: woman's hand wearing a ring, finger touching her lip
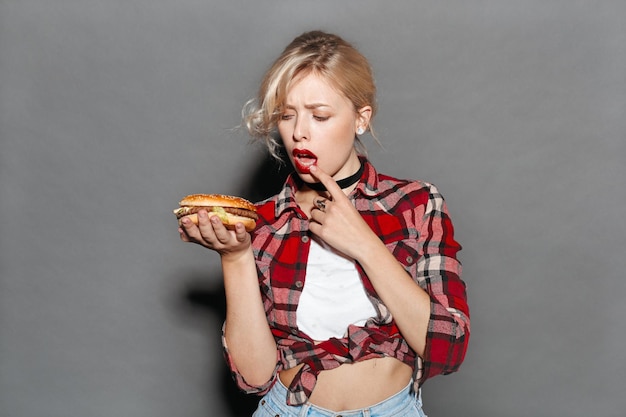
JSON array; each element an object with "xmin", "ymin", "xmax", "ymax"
[{"xmin": 309, "ymin": 166, "xmax": 380, "ymax": 260}]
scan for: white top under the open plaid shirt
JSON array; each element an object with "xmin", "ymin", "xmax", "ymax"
[{"xmin": 296, "ymin": 239, "xmax": 376, "ymax": 341}]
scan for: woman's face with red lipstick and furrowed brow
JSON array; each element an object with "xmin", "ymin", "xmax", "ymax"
[{"xmin": 278, "ymin": 74, "xmax": 371, "ymax": 182}]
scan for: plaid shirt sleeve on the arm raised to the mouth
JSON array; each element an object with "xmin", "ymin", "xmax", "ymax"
[{"xmin": 417, "ymin": 185, "xmax": 470, "ymax": 383}]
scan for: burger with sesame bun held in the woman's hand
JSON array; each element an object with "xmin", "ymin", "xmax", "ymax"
[{"xmin": 174, "ymin": 194, "xmax": 258, "ymax": 232}]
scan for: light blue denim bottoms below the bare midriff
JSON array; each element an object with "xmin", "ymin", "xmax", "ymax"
[{"xmin": 252, "ymin": 378, "xmax": 426, "ymax": 417}]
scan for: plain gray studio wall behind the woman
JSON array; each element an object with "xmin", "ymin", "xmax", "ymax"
[{"xmin": 0, "ymin": 0, "xmax": 626, "ymax": 417}]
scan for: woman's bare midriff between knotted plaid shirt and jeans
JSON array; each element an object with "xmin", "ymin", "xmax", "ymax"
[{"xmin": 279, "ymin": 357, "xmax": 413, "ymax": 411}]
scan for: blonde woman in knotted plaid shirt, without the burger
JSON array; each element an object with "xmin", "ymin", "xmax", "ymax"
[{"xmin": 179, "ymin": 32, "xmax": 469, "ymax": 416}]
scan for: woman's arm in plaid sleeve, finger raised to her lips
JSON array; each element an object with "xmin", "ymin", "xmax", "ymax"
[{"xmin": 310, "ymin": 165, "xmax": 469, "ymax": 370}]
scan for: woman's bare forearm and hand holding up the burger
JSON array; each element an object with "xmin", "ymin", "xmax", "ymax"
[{"xmin": 179, "ymin": 211, "xmax": 277, "ymax": 386}]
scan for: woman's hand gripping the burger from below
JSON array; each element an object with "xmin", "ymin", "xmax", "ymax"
[{"xmin": 178, "ymin": 210, "xmax": 251, "ymax": 260}]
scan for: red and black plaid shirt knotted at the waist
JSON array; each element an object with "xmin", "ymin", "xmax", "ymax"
[{"xmin": 223, "ymin": 161, "xmax": 470, "ymax": 405}]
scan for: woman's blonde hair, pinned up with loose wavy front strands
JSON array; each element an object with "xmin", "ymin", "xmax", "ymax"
[{"xmin": 243, "ymin": 31, "xmax": 376, "ymax": 160}]
